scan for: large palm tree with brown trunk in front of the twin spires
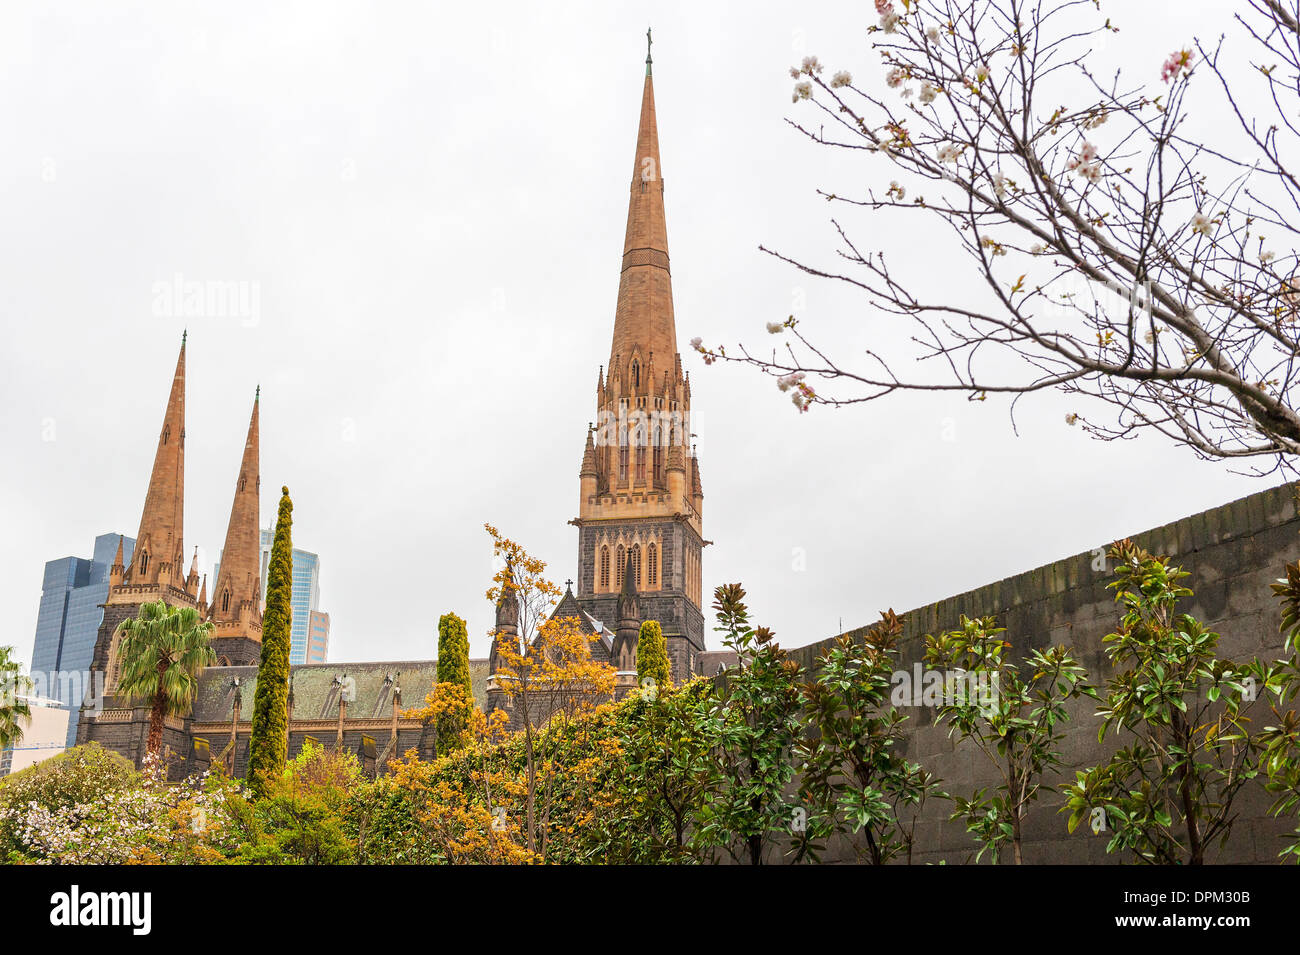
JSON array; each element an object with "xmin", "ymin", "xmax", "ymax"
[{"xmin": 116, "ymin": 600, "xmax": 217, "ymax": 756}]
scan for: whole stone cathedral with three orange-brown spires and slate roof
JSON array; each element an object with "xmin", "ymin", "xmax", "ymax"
[{"xmin": 77, "ymin": 41, "xmax": 728, "ymax": 774}]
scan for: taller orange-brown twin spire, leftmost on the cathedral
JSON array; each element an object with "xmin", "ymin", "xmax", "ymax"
[{"xmin": 122, "ymin": 335, "xmax": 185, "ymax": 587}]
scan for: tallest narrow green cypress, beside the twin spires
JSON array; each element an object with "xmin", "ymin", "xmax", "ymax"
[{"xmin": 248, "ymin": 487, "xmax": 294, "ymax": 794}]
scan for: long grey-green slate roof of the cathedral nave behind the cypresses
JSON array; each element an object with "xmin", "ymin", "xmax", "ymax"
[{"xmin": 194, "ymin": 660, "xmax": 488, "ymax": 722}]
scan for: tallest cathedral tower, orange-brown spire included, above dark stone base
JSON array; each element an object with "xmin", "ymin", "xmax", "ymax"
[{"xmin": 573, "ymin": 42, "xmax": 707, "ymax": 681}]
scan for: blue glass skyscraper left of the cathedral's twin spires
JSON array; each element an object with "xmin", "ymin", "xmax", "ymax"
[{"xmin": 31, "ymin": 534, "xmax": 135, "ymax": 746}]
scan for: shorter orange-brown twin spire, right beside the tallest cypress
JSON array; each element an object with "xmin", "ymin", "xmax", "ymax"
[{"xmin": 209, "ymin": 388, "xmax": 261, "ymax": 639}]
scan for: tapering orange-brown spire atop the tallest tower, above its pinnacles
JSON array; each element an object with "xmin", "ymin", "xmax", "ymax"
[{"xmin": 610, "ymin": 49, "xmax": 677, "ymax": 378}]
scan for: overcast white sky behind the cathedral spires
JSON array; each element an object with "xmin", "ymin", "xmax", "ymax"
[{"xmin": 0, "ymin": 0, "xmax": 1281, "ymax": 661}]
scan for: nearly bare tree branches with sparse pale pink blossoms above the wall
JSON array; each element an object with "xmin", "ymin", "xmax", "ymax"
[{"xmin": 692, "ymin": 0, "xmax": 1300, "ymax": 472}]
